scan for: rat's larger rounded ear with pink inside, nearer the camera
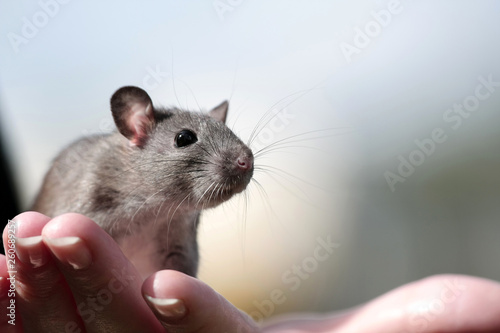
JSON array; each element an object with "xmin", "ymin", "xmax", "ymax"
[{"xmin": 111, "ymin": 86, "xmax": 155, "ymax": 146}]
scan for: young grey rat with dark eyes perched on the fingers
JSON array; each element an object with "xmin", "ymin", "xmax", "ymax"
[{"xmin": 32, "ymin": 86, "xmax": 254, "ymax": 278}]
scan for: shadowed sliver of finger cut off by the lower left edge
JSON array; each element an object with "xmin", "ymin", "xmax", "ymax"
[{"xmin": 0, "ymin": 254, "xmax": 22, "ymax": 333}]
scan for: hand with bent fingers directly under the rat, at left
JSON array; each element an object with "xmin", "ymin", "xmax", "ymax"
[{"xmin": 0, "ymin": 212, "xmax": 258, "ymax": 333}]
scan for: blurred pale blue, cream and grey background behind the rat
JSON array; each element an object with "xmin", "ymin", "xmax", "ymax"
[{"xmin": 0, "ymin": 0, "xmax": 500, "ymax": 321}]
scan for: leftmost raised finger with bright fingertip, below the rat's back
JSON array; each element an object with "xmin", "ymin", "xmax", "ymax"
[{"xmin": 3, "ymin": 212, "xmax": 83, "ymax": 333}]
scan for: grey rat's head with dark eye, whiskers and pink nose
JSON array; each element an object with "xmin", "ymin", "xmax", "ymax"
[{"xmin": 111, "ymin": 87, "xmax": 254, "ymax": 209}]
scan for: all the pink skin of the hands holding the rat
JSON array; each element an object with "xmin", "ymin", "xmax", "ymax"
[{"xmin": 0, "ymin": 212, "xmax": 500, "ymax": 333}]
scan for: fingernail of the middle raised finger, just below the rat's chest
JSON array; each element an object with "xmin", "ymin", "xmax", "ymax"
[{"xmin": 44, "ymin": 237, "xmax": 92, "ymax": 269}]
